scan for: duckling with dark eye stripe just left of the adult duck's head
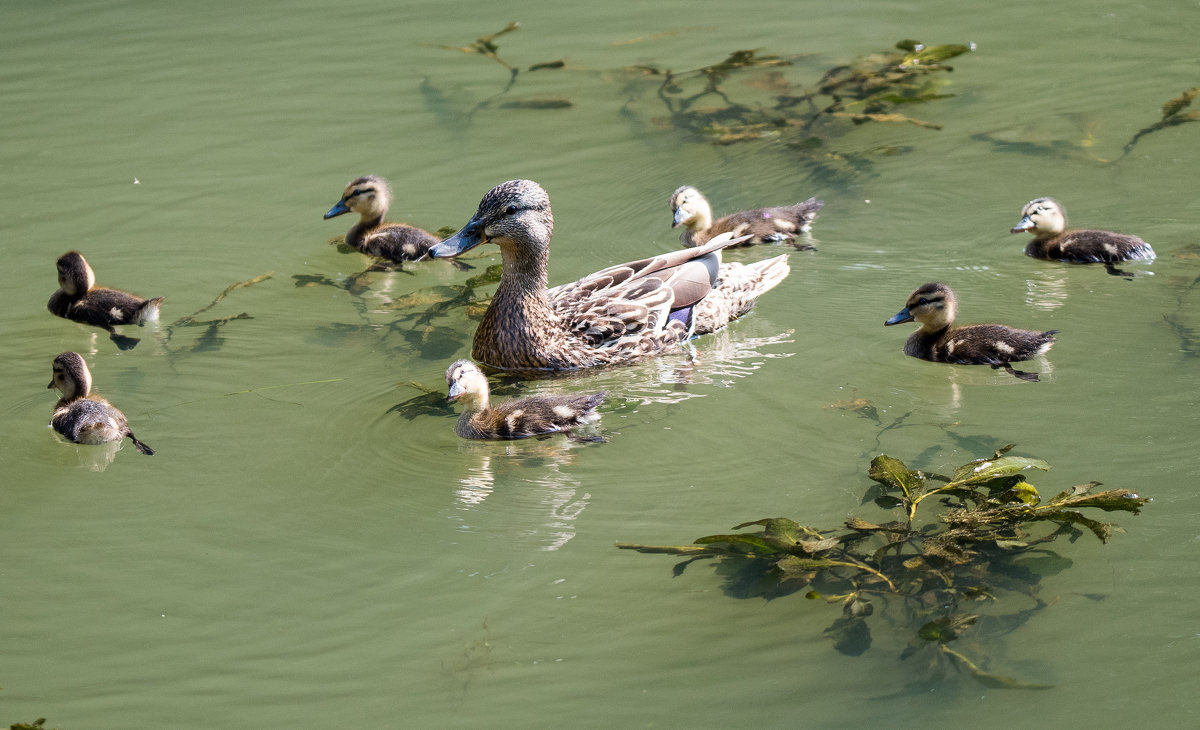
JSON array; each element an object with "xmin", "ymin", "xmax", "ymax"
[{"xmin": 325, "ymin": 175, "xmax": 442, "ymax": 262}]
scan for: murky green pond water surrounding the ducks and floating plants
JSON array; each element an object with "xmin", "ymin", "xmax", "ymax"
[{"xmin": 0, "ymin": 1, "xmax": 1200, "ymax": 729}]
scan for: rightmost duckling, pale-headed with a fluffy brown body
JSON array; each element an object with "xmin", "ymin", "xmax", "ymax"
[{"xmin": 1010, "ymin": 198, "xmax": 1154, "ymax": 277}]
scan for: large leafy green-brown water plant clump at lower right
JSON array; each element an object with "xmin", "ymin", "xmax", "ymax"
[{"xmin": 617, "ymin": 444, "xmax": 1150, "ymax": 689}]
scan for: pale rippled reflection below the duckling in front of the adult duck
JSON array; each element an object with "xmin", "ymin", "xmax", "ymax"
[{"xmin": 455, "ymin": 436, "xmax": 592, "ymax": 550}]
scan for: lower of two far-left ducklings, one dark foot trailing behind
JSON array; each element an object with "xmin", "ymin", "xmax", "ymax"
[{"xmin": 47, "ymin": 352, "xmax": 154, "ymax": 456}]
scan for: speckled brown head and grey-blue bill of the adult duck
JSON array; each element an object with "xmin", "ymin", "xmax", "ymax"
[{"xmin": 430, "ymin": 180, "xmax": 554, "ymax": 261}]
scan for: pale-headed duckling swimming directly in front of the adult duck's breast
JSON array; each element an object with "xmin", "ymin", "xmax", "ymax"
[{"xmin": 446, "ymin": 360, "xmax": 607, "ymax": 439}]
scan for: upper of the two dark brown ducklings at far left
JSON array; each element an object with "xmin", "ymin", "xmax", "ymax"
[{"xmin": 46, "ymin": 251, "xmax": 163, "ymax": 349}]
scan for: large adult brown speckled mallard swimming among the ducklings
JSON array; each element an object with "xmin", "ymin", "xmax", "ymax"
[{"xmin": 430, "ymin": 180, "xmax": 790, "ymax": 370}]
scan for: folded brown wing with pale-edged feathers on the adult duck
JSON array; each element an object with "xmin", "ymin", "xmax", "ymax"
[{"xmin": 546, "ymin": 235, "xmax": 740, "ymax": 347}]
